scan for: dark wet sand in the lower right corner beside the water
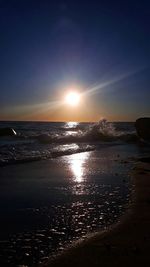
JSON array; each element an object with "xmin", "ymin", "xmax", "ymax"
[{"xmin": 42, "ymin": 162, "xmax": 150, "ymax": 267}]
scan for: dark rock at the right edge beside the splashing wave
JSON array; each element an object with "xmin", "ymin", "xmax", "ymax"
[{"xmin": 135, "ymin": 118, "xmax": 150, "ymax": 140}]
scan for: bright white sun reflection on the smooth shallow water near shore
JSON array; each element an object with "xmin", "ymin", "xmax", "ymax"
[{"xmin": 70, "ymin": 152, "xmax": 89, "ymax": 183}]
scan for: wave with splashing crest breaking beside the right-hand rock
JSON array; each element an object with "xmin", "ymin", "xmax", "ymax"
[{"xmin": 37, "ymin": 119, "xmax": 137, "ymax": 144}]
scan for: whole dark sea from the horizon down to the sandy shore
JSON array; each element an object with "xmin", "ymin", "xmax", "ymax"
[{"xmin": 0, "ymin": 119, "xmax": 149, "ymax": 267}]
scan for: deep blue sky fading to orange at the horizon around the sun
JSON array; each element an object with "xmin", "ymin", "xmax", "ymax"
[{"xmin": 0, "ymin": 0, "xmax": 150, "ymax": 121}]
